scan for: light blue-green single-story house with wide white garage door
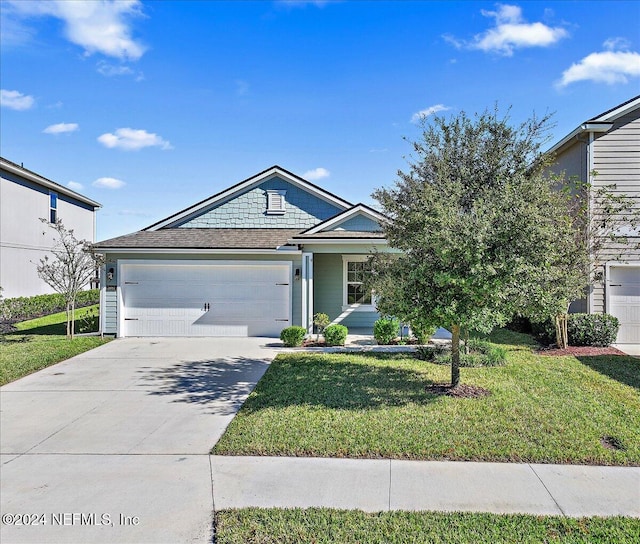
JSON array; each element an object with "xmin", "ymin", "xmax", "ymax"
[{"xmin": 95, "ymin": 166, "xmax": 387, "ymax": 337}]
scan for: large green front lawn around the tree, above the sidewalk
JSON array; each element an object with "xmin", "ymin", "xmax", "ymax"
[{"xmin": 213, "ymin": 332, "xmax": 640, "ymax": 465}]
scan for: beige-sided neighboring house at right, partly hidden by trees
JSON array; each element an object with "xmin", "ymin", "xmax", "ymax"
[{"xmin": 550, "ymin": 96, "xmax": 640, "ymax": 344}]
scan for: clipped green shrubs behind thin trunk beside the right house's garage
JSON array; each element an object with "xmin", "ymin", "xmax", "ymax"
[{"xmin": 533, "ymin": 314, "xmax": 620, "ymax": 346}]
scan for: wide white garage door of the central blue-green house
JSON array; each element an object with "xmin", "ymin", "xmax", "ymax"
[{"xmin": 120, "ymin": 263, "xmax": 291, "ymax": 336}]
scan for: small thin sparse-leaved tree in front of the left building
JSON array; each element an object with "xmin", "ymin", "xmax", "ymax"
[{"xmin": 37, "ymin": 219, "xmax": 102, "ymax": 338}]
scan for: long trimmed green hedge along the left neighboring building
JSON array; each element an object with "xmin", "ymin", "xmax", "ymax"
[{"xmin": 0, "ymin": 289, "xmax": 100, "ymax": 322}]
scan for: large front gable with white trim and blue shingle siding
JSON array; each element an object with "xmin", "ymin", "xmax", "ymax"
[{"xmin": 144, "ymin": 166, "xmax": 351, "ymax": 231}]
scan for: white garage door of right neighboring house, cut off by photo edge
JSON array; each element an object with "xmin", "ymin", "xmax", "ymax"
[{"xmin": 609, "ymin": 266, "xmax": 640, "ymax": 344}]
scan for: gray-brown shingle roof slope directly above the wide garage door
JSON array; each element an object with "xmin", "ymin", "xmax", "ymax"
[{"xmin": 94, "ymin": 228, "xmax": 300, "ymax": 249}]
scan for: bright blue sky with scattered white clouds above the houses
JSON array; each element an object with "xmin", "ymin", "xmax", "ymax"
[{"xmin": 0, "ymin": 0, "xmax": 640, "ymax": 240}]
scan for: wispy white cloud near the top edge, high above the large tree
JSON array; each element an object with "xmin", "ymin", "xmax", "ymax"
[{"xmin": 444, "ymin": 4, "xmax": 569, "ymax": 57}]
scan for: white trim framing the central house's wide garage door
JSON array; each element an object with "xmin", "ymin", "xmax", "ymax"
[{"xmin": 116, "ymin": 259, "xmax": 294, "ymax": 338}]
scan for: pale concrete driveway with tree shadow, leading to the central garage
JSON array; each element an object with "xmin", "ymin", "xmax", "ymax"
[{"xmin": 0, "ymin": 338, "xmax": 277, "ymax": 543}]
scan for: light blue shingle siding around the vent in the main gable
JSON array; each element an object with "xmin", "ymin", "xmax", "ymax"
[{"xmin": 178, "ymin": 177, "xmax": 343, "ymax": 230}]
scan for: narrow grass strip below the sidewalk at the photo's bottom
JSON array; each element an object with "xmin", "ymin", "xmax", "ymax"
[{"xmin": 216, "ymin": 508, "xmax": 640, "ymax": 544}]
